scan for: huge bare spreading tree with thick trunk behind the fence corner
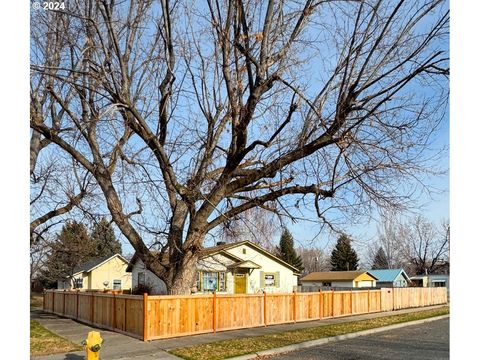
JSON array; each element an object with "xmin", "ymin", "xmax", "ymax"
[{"xmin": 31, "ymin": 0, "xmax": 448, "ymax": 294}]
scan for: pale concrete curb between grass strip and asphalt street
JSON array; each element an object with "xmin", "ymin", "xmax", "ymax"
[{"xmin": 228, "ymin": 314, "xmax": 450, "ymax": 360}]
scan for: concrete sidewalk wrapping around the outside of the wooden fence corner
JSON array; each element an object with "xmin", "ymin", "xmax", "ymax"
[{"xmin": 31, "ymin": 305, "xmax": 445, "ymax": 360}]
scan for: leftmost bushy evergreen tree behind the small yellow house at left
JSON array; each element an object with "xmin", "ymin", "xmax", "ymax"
[{"xmin": 40, "ymin": 221, "xmax": 97, "ymax": 287}]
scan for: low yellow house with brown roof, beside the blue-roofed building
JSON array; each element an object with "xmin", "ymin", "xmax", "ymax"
[{"xmin": 300, "ymin": 271, "xmax": 377, "ymax": 288}]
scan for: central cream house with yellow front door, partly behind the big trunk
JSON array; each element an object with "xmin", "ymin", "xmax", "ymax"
[{"xmin": 127, "ymin": 241, "xmax": 299, "ymax": 294}]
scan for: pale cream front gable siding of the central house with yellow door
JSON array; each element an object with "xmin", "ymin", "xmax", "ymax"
[{"xmin": 227, "ymin": 244, "xmax": 297, "ymax": 294}]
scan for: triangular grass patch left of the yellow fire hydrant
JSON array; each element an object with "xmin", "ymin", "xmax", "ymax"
[{"xmin": 30, "ymin": 320, "xmax": 83, "ymax": 356}]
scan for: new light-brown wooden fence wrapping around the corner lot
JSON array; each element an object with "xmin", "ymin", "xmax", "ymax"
[{"xmin": 43, "ymin": 288, "xmax": 447, "ymax": 341}]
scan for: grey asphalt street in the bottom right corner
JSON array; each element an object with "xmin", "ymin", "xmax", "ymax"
[{"xmin": 274, "ymin": 318, "xmax": 450, "ymax": 360}]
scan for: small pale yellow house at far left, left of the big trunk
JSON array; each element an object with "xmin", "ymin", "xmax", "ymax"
[{"xmin": 57, "ymin": 254, "xmax": 132, "ymax": 290}]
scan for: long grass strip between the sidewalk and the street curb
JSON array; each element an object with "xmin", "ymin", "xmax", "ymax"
[{"xmin": 171, "ymin": 306, "xmax": 449, "ymax": 360}]
